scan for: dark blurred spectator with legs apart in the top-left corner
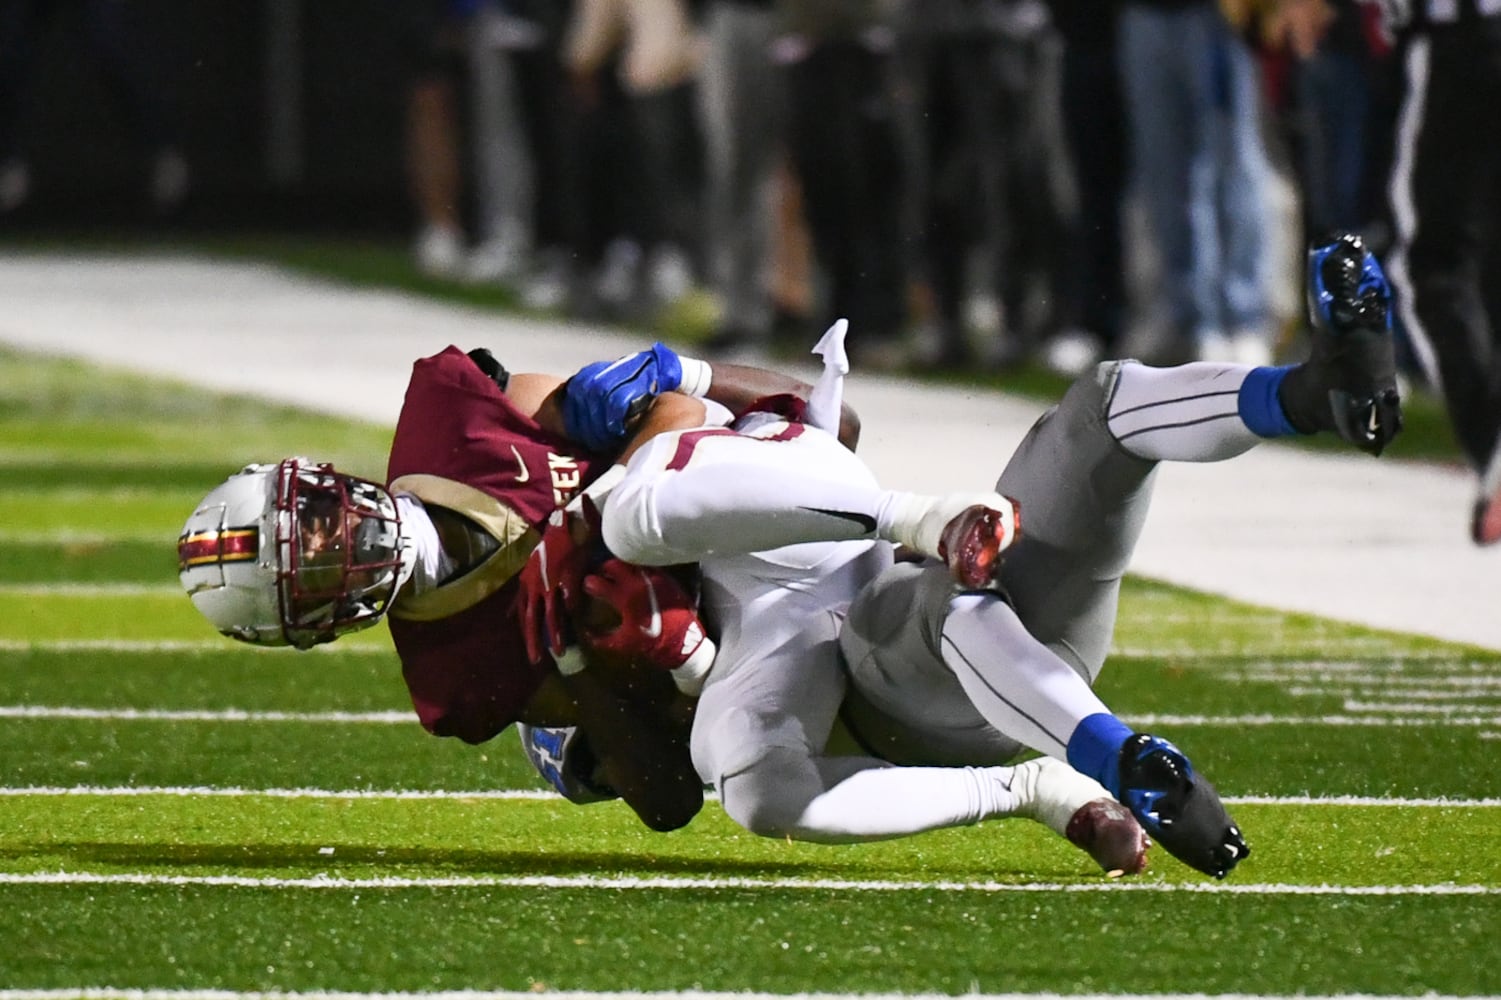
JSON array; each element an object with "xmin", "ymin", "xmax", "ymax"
[{"xmin": 0, "ymin": 0, "xmax": 189, "ymax": 215}]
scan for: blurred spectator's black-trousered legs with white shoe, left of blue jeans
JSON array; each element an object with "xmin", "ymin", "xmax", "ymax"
[{"xmin": 1043, "ymin": 0, "xmax": 1130, "ymax": 375}]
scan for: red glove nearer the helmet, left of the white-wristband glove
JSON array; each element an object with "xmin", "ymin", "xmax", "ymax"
[{"xmin": 516, "ymin": 497, "xmax": 599, "ymax": 664}]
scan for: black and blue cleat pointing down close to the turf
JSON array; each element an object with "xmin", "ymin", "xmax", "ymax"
[{"xmin": 1120, "ymin": 733, "xmax": 1250, "ymax": 878}]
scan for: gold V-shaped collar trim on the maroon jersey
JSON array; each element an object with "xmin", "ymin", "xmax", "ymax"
[{"xmin": 390, "ymin": 473, "xmax": 542, "ymax": 622}]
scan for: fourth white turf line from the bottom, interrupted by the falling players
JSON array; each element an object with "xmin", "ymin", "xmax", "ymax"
[{"xmin": 0, "ymin": 699, "xmax": 1501, "ymax": 728}]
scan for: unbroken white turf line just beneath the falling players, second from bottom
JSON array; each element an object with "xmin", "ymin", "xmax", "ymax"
[{"xmin": 0, "ymin": 871, "xmax": 1501, "ymax": 896}]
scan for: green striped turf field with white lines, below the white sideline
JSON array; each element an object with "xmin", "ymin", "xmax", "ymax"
[{"xmin": 0, "ymin": 340, "xmax": 1501, "ymax": 1000}]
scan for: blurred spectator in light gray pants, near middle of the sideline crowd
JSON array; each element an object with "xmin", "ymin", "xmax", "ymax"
[{"xmin": 698, "ymin": 0, "xmax": 787, "ymax": 354}]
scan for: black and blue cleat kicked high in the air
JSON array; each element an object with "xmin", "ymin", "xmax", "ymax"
[{"xmin": 1307, "ymin": 233, "xmax": 1402, "ymax": 455}]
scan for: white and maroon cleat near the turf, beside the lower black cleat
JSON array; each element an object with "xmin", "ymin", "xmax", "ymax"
[{"xmin": 1012, "ymin": 757, "xmax": 1151, "ymax": 878}]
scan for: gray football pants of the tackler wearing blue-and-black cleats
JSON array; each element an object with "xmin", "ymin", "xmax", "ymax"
[{"xmin": 839, "ymin": 362, "xmax": 1157, "ymax": 764}]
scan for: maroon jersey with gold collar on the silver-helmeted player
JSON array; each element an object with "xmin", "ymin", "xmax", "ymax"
[{"xmin": 386, "ymin": 347, "xmax": 608, "ymax": 743}]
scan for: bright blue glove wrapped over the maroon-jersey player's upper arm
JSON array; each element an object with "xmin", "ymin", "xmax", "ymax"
[{"xmin": 563, "ymin": 344, "xmax": 683, "ymax": 452}]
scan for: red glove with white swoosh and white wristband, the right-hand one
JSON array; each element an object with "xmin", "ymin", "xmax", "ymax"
[{"xmin": 584, "ymin": 559, "xmax": 713, "ymax": 673}]
